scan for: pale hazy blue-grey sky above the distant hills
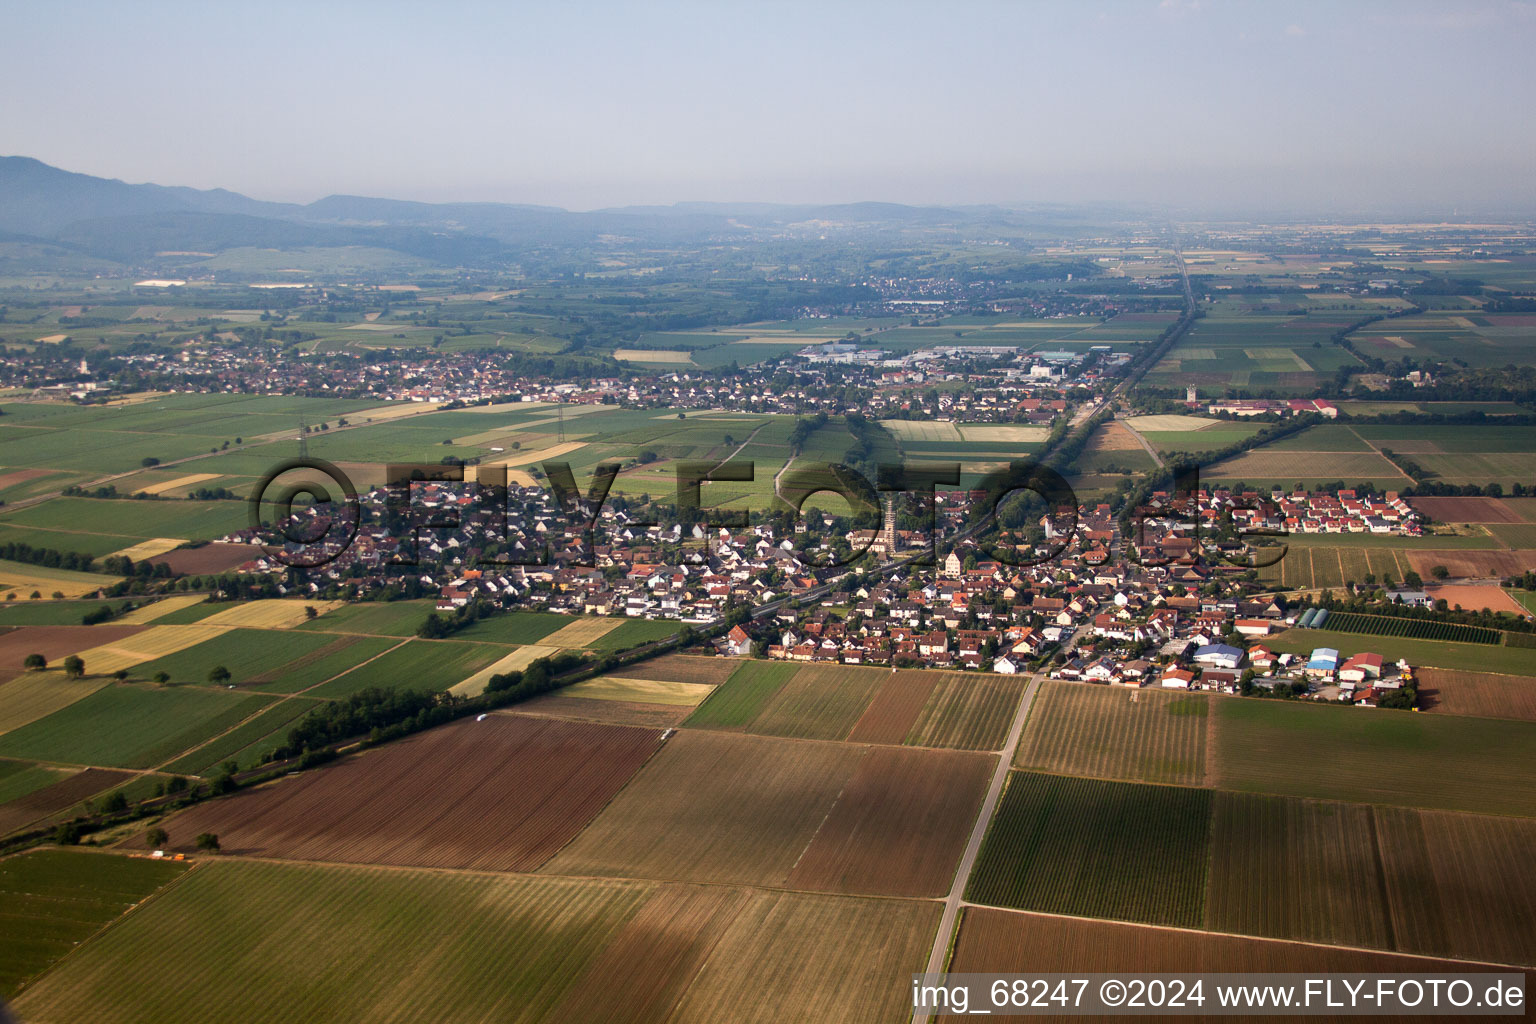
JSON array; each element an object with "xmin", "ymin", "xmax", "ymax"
[{"xmin": 0, "ymin": 0, "xmax": 1536, "ymax": 210}]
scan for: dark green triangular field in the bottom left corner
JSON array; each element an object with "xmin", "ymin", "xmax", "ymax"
[{"xmin": 0, "ymin": 849, "xmax": 186, "ymax": 1000}]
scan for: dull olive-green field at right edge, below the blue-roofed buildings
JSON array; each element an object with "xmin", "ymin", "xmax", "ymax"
[{"xmin": 1215, "ymin": 700, "xmax": 1536, "ymax": 817}]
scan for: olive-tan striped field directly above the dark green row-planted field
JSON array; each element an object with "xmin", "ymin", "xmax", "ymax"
[{"xmin": 1014, "ymin": 682, "xmax": 1210, "ymax": 786}]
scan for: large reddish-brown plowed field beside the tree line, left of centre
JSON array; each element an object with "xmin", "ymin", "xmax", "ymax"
[{"xmin": 166, "ymin": 715, "xmax": 660, "ymax": 870}]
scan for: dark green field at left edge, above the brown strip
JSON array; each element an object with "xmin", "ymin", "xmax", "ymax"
[{"xmin": 0, "ymin": 683, "xmax": 270, "ymax": 768}]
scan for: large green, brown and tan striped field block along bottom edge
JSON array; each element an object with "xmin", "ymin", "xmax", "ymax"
[{"xmin": 17, "ymin": 860, "xmax": 938, "ymax": 1024}]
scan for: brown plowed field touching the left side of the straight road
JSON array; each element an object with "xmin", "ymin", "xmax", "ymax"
[{"xmin": 785, "ymin": 746, "xmax": 995, "ymax": 897}]
